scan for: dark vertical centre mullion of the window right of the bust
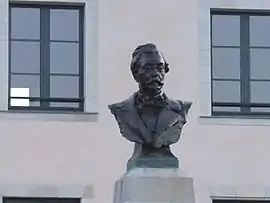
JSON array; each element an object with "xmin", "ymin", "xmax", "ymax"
[{"xmin": 240, "ymin": 14, "xmax": 250, "ymax": 112}]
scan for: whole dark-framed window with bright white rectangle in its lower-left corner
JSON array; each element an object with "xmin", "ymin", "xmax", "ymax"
[{"xmin": 9, "ymin": 4, "xmax": 84, "ymax": 111}]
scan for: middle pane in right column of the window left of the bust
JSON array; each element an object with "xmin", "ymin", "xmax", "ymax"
[{"xmin": 50, "ymin": 42, "xmax": 79, "ymax": 74}]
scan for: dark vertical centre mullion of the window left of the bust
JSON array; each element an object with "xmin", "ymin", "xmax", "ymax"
[{"xmin": 40, "ymin": 7, "xmax": 50, "ymax": 109}]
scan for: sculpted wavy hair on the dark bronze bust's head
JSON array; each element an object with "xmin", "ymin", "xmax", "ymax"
[{"xmin": 130, "ymin": 43, "xmax": 169, "ymax": 76}]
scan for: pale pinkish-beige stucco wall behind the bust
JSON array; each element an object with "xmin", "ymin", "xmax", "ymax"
[{"xmin": 0, "ymin": 0, "xmax": 270, "ymax": 203}]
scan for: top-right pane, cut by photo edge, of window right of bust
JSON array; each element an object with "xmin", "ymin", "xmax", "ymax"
[{"xmin": 250, "ymin": 16, "xmax": 270, "ymax": 46}]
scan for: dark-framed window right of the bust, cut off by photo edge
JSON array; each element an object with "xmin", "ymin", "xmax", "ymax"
[{"xmin": 211, "ymin": 11, "xmax": 270, "ymax": 116}]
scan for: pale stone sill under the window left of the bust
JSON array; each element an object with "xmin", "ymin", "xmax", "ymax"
[{"xmin": 0, "ymin": 110, "xmax": 98, "ymax": 122}]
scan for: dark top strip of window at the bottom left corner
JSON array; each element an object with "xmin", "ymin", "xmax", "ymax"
[{"xmin": 3, "ymin": 197, "xmax": 80, "ymax": 203}]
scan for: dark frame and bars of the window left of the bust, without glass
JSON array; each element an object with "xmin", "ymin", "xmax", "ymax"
[{"xmin": 8, "ymin": 1, "xmax": 85, "ymax": 112}]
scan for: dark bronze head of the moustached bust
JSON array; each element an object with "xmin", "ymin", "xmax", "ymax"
[{"xmin": 130, "ymin": 43, "xmax": 169, "ymax": 96}]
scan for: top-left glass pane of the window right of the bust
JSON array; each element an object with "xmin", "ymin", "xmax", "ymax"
[{"xmin": 212, "ymin": 15, "xmax": 240, "ymax": 46}]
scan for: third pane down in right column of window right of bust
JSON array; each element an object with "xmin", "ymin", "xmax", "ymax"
[{"xmin": 250, "ymin": 82, "xmax": 270, "ymax": 103}]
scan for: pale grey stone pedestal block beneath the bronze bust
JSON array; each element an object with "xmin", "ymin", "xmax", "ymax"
[{"xmin": 114, "ymin": 168, "xmax": 195, "ymax": 203}]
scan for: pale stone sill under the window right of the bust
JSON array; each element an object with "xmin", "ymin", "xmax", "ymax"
[{"xmin": 199, "ymin": 116, "xmax": 270, "ymax": 126}]
